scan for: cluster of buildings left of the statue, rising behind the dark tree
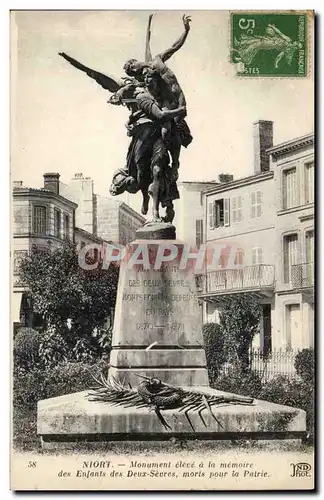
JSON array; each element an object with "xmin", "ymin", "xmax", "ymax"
[{"xmin": 11, "ymin": 173, "xmax": 145, "ymax": 326}]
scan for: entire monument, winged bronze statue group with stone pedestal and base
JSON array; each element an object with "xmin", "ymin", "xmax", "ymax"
[{"xmin": 37, "ymin": 16, "xmax": 306, "ymax": 447}]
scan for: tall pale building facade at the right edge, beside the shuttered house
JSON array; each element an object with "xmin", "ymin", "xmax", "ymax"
[{"xmin": 268, "ymin": 134, "xmax": 315, "ymax": 348}]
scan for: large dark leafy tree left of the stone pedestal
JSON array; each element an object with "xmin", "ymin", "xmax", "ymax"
[{"xmin": 20, "ymin": 242, "xmax": 118, "ymax": 356}]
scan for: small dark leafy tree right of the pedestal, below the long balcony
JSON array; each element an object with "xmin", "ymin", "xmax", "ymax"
[{"xmin": 219, "ymin": 294, "xmax": 261, "ymax": 371}]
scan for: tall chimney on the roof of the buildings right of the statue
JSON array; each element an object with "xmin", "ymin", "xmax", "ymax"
[{"xmin": 253, "ymin": 120, "xmax": 273, "ymax": 174}]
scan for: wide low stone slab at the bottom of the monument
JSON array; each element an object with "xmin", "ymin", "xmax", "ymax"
[{"xmin": 37, "ymin": 387, "xmax": 306, "ymax": 447}]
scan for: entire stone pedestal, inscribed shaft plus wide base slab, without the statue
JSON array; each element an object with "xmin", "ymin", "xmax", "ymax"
[{"xmin": 37, "ymin": 224, "xmax": 306, "ymax": 448}]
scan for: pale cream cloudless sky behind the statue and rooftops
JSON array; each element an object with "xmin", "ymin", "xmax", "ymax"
[{"xmin": 11, "ymin": 11, "xmax": 314, "ymax": 209}]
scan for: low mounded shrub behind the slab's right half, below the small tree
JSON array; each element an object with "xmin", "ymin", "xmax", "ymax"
[{"xmin": 214, "ymin": 368, "xmax": 262, "ymax": 398}]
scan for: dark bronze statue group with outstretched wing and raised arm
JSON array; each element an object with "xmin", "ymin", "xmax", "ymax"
[{"xmin": 60, "ymin": 15, "xmax": 192, "ymax": 223}]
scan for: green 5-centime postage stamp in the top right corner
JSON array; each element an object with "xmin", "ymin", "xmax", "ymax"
[{"xmin": 231, "ymin": 11, "xmax": 307, "ymax": 77}]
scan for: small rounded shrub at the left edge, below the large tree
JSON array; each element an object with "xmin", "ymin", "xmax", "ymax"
[{"xmin": 13, "ymin": 328, "xmax": 40, "ymax": 370}]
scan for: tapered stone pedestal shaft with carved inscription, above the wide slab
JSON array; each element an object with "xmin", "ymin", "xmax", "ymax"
[{"xmin": 109, "ymin": 240, "xmax": 209, "ymax": 386}]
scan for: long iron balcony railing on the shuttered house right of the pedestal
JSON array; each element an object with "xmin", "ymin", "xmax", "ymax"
[{"xmin": 196, "ymin": 264, "xmax": 275, "ymax": 293}]
